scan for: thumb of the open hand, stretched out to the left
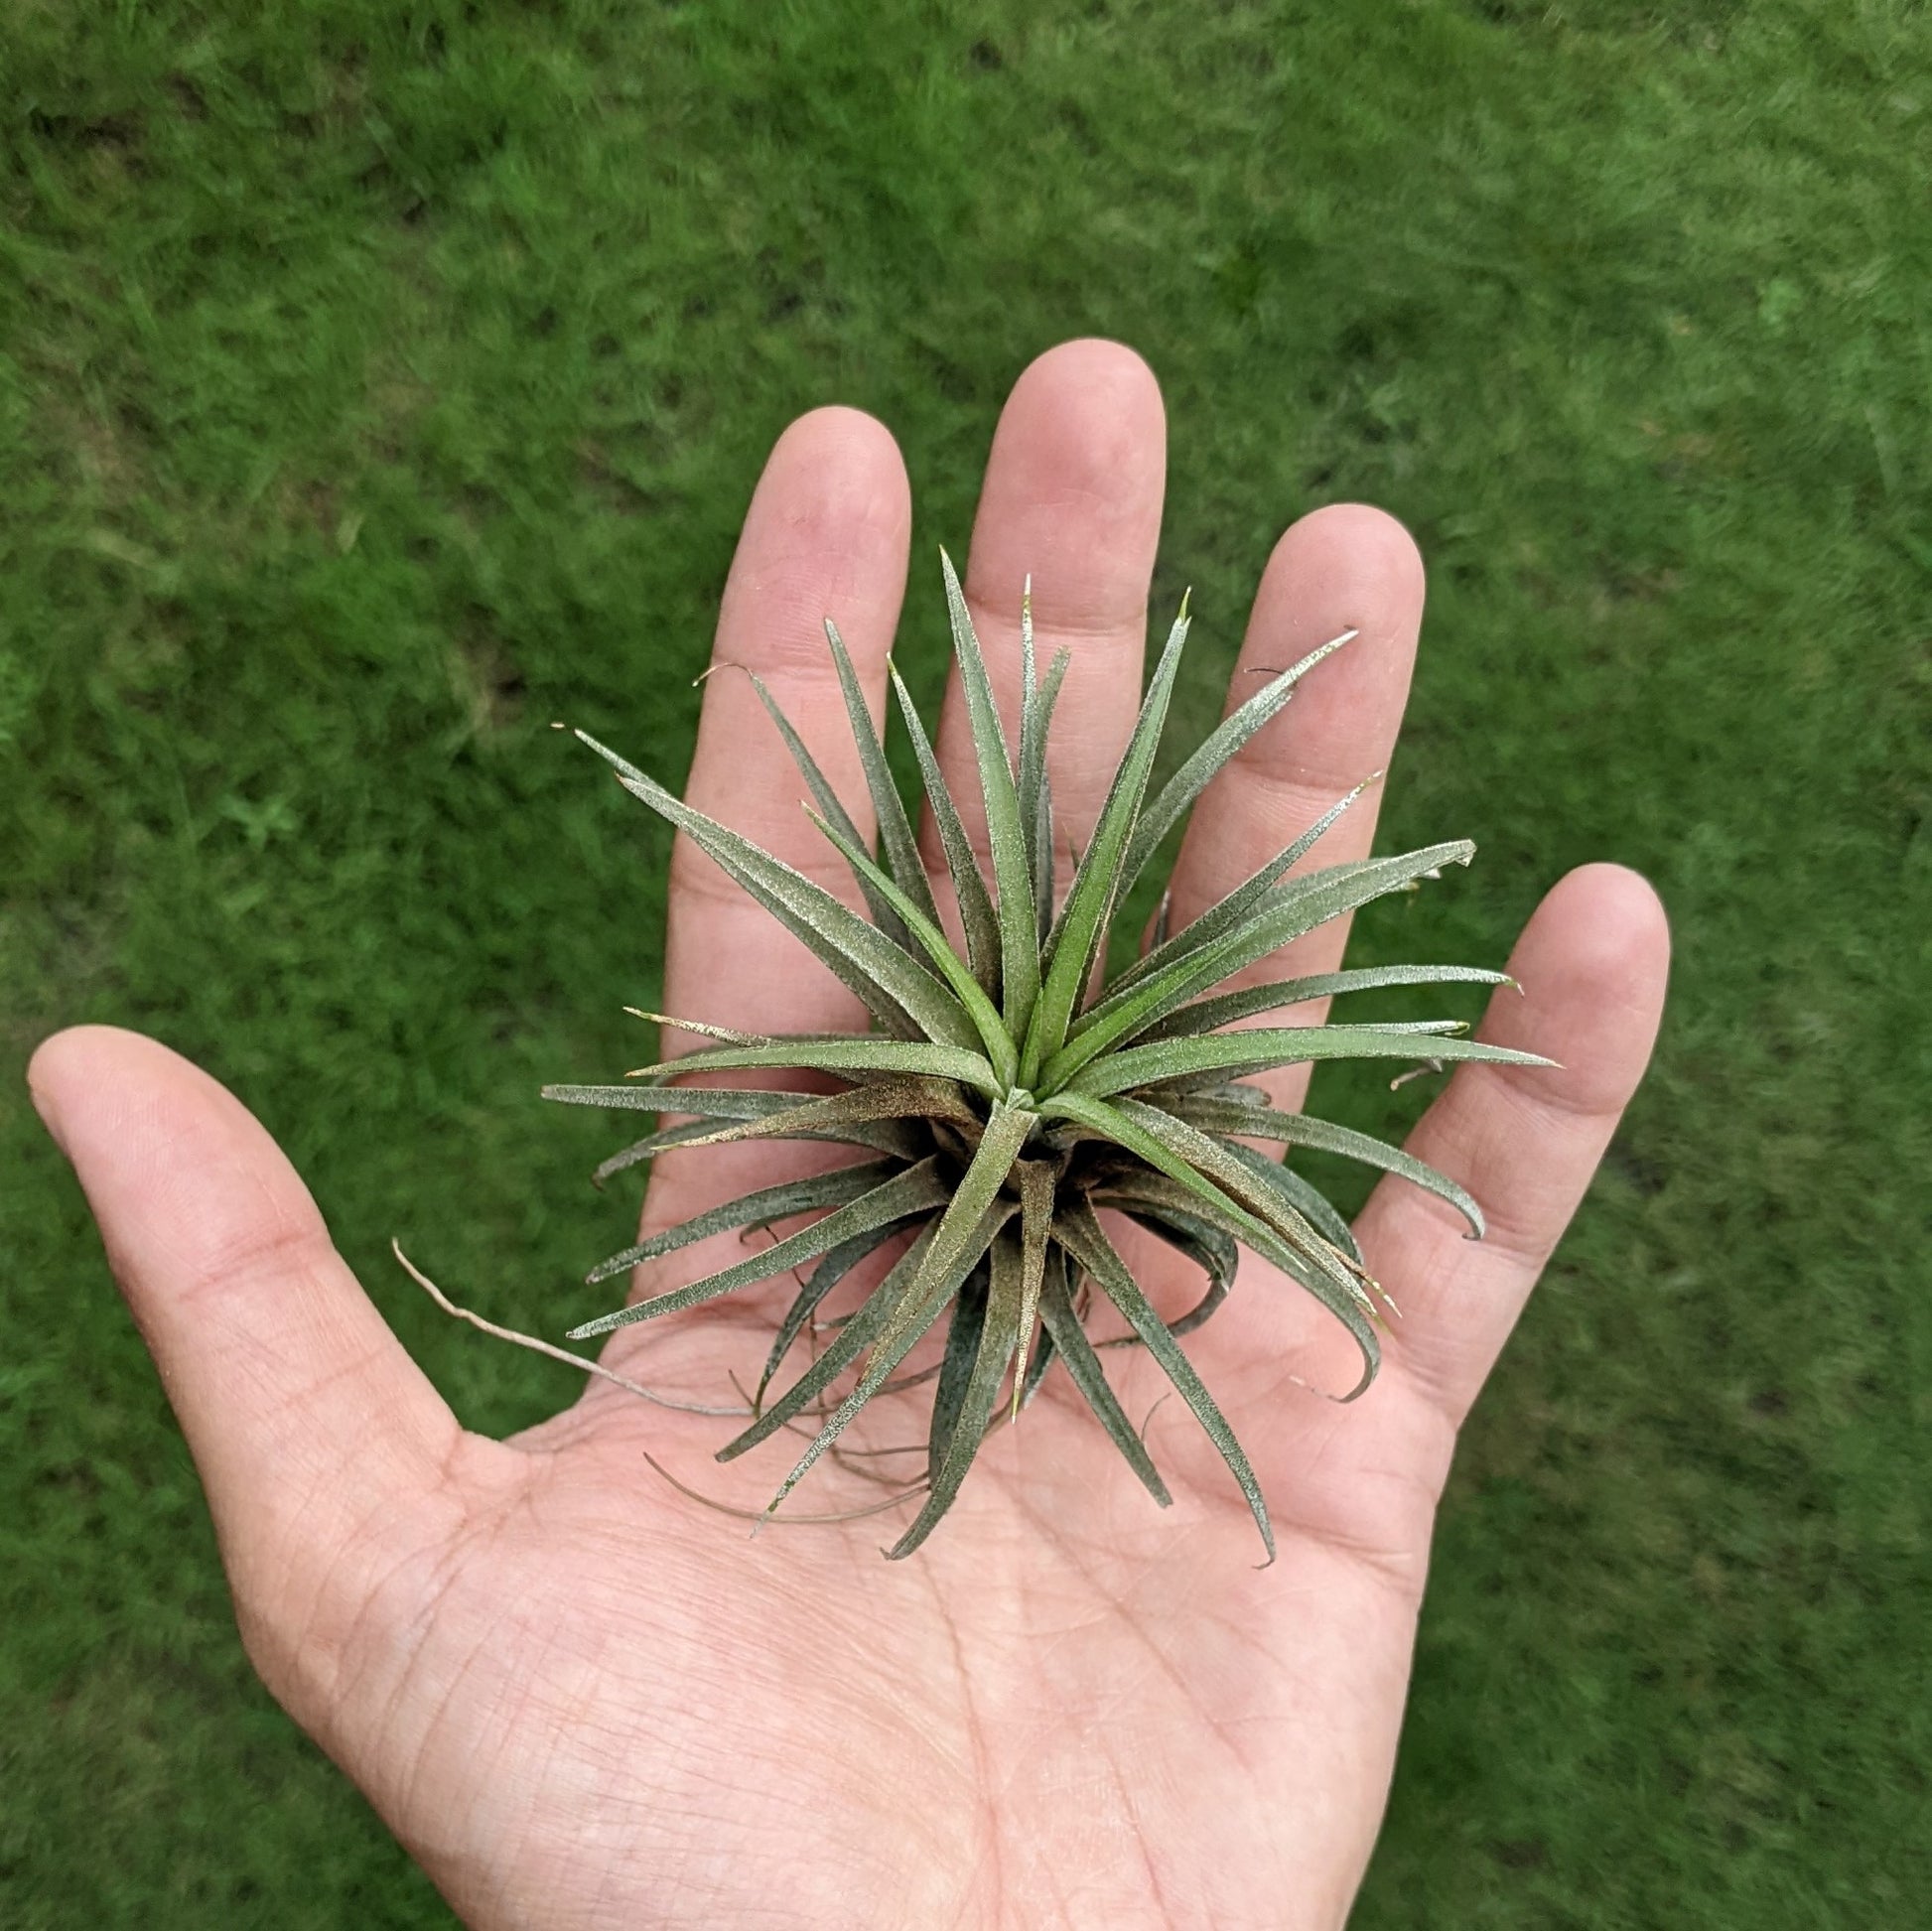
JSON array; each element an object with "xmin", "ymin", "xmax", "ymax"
[{"xmin": 27, "ymin": 1027, "xmax": 460, "ymax": 1685}]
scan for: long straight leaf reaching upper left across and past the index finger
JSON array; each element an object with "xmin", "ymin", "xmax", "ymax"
[{"xmin": 578, "ymin": 731, "xmax": 976, "ymax": 1045}]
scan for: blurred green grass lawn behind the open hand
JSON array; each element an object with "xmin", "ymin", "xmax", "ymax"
[{"xmin": 0, "ymin": 0, "xmax": 1932, "ymax": 1931}]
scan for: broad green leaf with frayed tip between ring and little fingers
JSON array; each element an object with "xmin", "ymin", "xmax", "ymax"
[{"xmin": 1022, "ymin": 841, "xmax": 1476, "ymax": 1092}]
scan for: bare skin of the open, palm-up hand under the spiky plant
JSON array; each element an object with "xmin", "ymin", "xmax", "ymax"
[{"xmin": 31, "ymin": 343, "xmax": 1667, "ymax": 1931}]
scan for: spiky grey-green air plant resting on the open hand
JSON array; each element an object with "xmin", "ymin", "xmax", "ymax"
[{"xmin": 545, "ymin": 557, "xmax": 1548, "ymax": 1556}]
